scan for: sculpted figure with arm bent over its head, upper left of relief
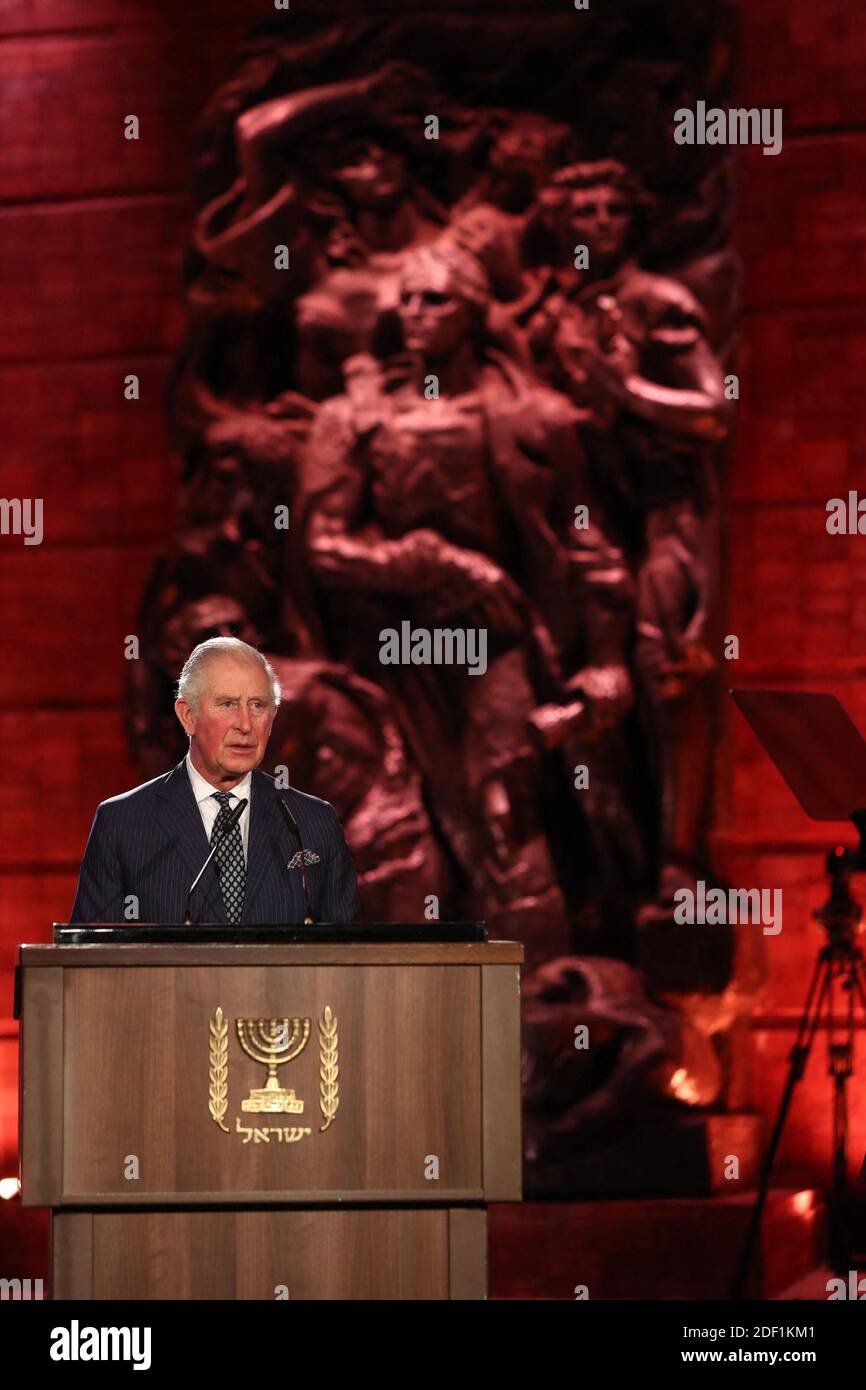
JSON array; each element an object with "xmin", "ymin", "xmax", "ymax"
[{"xmin": 195, "ymin": 63, "xmax": 448, "ymax": 399}]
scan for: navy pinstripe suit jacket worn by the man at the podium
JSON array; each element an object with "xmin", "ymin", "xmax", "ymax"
[{"xmin": 70, "ymin": 762, "xmax": 360, "ymax": 926}]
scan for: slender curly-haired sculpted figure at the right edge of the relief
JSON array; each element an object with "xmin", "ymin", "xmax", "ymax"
[{"xmin": 528, "ymin": 160, "xmax": 727, "ymax": 898}]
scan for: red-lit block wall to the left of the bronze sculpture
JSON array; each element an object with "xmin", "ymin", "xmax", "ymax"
[{"xmin": 0, "ymin": 0, "xmax": 252, "ymax": 1176}]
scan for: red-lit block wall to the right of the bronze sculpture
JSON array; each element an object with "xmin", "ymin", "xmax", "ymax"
[{"xmin": 717, "ymin": 0, "xmax": 866, "ymax": 1180}]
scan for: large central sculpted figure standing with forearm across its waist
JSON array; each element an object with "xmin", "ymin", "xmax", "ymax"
[{"xmin": 302, "ymin": 240, "xmax": 622, "ymax": 959}]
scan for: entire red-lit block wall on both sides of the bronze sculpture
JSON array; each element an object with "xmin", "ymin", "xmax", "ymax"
[{"xmin": 0, "ymin": 0, "xmax": 866, "ymax": 1200}]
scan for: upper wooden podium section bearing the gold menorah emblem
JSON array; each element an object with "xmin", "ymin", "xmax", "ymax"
[{"xmin": 22, "ymin": 945, "xmax": 520, "ymax": 1207}]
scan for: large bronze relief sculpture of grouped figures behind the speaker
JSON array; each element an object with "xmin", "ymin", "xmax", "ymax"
[{"xmin": 128, "ymin": 4, "xmax": 737, "ymax": 1187}]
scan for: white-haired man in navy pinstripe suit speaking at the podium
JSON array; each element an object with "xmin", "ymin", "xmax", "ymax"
[{"xmin": 70, "ymin": 637, "xmax": 359, "ymax": 926}]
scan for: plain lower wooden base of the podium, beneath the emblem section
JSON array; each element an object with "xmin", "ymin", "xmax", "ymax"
[{"xmin": 51, "ymin": 1207, "xmax": 487, "ymax": 1302}]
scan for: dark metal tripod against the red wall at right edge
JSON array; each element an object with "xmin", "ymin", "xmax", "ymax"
[{"xmin": 731, "ymin": 810, "xmax": 866, "ymax": 1300}]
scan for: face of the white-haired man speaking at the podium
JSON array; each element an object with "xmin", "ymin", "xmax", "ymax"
[{"xmin": 175, "ymin": 656, "xmax": 277, "ymax": 791}]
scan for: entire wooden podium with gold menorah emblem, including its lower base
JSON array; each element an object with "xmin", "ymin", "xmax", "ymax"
[{"xmin": 18, "ymin": 924, "xmax": 523, "ymax": 1300}]
